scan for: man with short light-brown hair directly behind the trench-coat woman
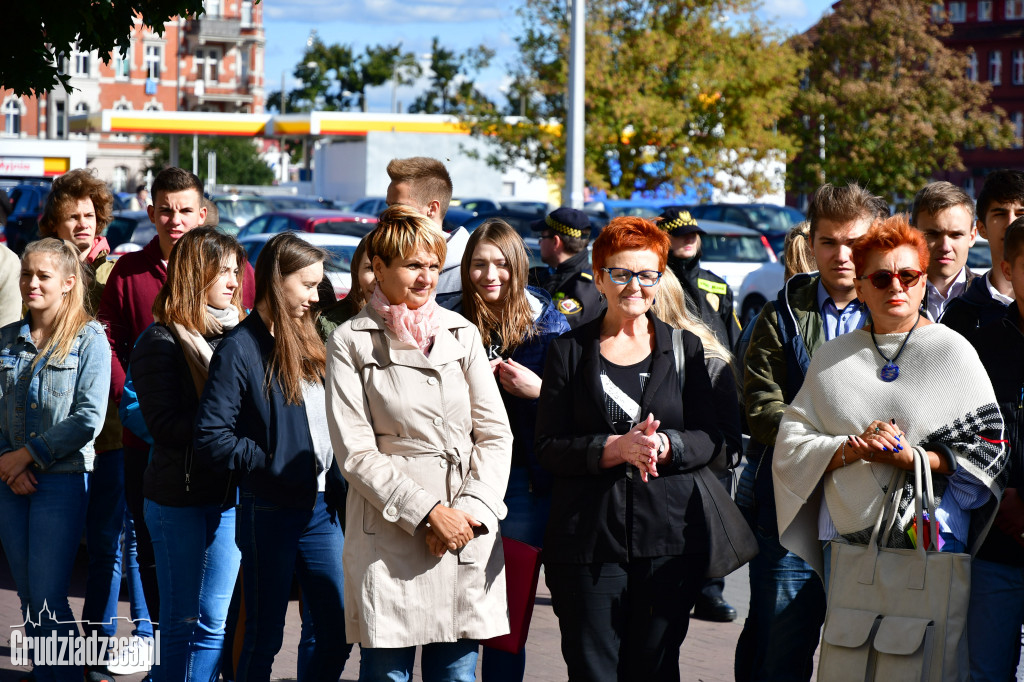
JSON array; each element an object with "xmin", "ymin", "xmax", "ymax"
[{"xmin": 386, "ymin": 157, "xmax": 469, "ymax": 304}]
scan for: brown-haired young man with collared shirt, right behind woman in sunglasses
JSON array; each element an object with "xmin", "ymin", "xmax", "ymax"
[{"xmin": 910, "ymin": 181, "xmax": 978, "ymax": 322}]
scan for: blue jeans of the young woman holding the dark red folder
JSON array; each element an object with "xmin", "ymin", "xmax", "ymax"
[{"xmin": 480, "ymin": 467, "xmax": 551, "ymax": 682}]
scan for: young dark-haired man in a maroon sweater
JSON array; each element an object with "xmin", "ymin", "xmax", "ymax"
[{"xmin": 96, "ymin": 168, "xmax": 256, "ymax": 634}]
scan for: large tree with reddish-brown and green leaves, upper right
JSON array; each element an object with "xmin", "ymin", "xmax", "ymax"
[{"xmin": 784, "ymin": 0, "xmax": 1013, "ymax": 204}]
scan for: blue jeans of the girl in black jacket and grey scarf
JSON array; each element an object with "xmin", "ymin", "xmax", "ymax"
[{"xmin": 145, "ymin": 499, "xmax": 241, "ymax": 682}]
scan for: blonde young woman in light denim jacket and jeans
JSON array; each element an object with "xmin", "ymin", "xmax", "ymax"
[{"xmin": 0, "ymin": 239, "xmax": 111, "ymax": 682}]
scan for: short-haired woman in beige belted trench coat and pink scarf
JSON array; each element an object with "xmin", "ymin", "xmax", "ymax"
[{"xmin": 327, "ymin": 206, "xmax": 512, "ymax": 680}]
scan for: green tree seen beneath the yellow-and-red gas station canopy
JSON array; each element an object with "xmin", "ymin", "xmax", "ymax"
[{"xmin": 145, "ymin": 135, "xmax": 273, "ymax": 184}]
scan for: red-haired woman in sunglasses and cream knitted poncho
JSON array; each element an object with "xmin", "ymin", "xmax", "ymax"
[{"xmin": 772, "ymin": 215, "xmax": 1007, "ymax": 589}]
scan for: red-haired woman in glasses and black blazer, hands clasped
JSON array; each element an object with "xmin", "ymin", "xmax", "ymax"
[{"xmin": 537, "ymin": 217, "xmax": 722, "ymax": 680}]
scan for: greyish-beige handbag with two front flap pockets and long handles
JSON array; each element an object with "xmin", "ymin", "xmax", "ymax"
[{"xmin": 818, "ymin": 447, "xmax": 971, "ymax": 682}]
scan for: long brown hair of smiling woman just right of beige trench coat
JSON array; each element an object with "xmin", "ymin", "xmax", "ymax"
[{"xmin": 462, "ymin": 218, "xmax": 537, "ymax": 351}]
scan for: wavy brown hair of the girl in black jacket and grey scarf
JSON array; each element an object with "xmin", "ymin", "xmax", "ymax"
[{"xmin": 153, "ymin": 227, "xmax": 246, "ymax": 334}]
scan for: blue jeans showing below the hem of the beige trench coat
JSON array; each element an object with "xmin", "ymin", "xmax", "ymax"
[{"xmin": 359, "ymin": 639, "xmax": 480, "ymax": 682}]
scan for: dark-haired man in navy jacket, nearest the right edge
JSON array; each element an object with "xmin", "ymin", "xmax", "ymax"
[{"xmin": 942, "ymin": 170, "xmax": 1024, "ymax": 331}]
